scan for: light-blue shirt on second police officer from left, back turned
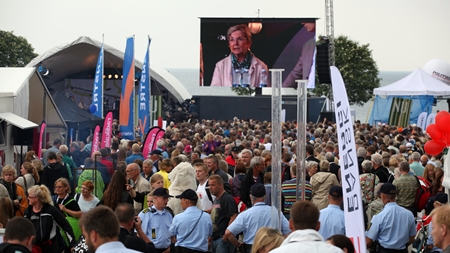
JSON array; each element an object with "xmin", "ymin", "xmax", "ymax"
[{"xmin": 169, "ymin": 206, "xmax": 212, "ymax": 252}]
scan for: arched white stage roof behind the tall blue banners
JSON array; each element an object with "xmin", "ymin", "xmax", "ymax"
[{"xmin": 27, "ymin": 36, "xmax": 191, "ymax": 102}]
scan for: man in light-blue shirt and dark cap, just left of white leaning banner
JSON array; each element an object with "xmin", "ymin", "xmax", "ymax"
[{"xmin": 319, "ymin": 186, "xmax": 345, "ymax": 240}]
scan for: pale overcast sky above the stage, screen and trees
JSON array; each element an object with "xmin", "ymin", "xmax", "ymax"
[{"xmin": 0, "ymin": 0, "xmax": 450, "ymax": 71}]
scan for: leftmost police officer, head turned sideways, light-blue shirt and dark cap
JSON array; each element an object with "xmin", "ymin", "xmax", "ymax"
[{"xmin": 139, "ymin": 188, "xmax": 173, "ymax": 253}]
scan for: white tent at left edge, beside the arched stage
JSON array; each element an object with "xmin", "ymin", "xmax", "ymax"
[{"xmin": 0, "ymin": 68, "xmax": 66, "ymax": 165}]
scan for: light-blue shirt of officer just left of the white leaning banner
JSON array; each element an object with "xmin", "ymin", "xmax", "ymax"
[{"xmin": 319, "ymin": 204, "xmax": 345, "ymax": 240}]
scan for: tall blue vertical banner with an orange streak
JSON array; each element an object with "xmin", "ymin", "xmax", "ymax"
[{"xmin": 119, "ymin": 37, "xmax": 134, "ymax": 140}]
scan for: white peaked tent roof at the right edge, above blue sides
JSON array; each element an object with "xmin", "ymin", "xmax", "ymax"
[{"xmin": 373, "ymin": 68, "xmax": 450, "ymax": 96}]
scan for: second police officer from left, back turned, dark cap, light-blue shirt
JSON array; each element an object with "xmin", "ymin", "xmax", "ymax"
[{"xmin": 169, "ymin": 189, "xmax": 212, "ymax": 253}]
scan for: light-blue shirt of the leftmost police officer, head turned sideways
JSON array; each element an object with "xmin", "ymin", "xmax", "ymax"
[{"xmin": 138, "ymin": 206, "xmax": 172, "ymax": 249}]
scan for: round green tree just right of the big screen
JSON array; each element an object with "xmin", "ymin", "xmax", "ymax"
[{"xmin": 311, "ymin": 36, "xmax": 381, "ymax": 105}]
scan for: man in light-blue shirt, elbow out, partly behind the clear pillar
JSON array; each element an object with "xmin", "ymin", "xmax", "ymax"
[{"xmin": 225, "ymin": 183, "xmax": 291, "ymax": 253}]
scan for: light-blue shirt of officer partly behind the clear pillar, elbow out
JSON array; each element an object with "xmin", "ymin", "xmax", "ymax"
[{"xmin": 227, "ymin": 202, "xmax": 291, "ymax": 244}]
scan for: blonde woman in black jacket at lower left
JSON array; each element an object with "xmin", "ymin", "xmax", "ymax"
[{"xmin": 24, "ymin": 185, "xmax": 76, "ymax": 253}]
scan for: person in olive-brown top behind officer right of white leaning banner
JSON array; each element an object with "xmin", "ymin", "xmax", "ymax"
[{"xmin": 393, "ymin": 162, "xmax": 419, "ymax": 217}]
